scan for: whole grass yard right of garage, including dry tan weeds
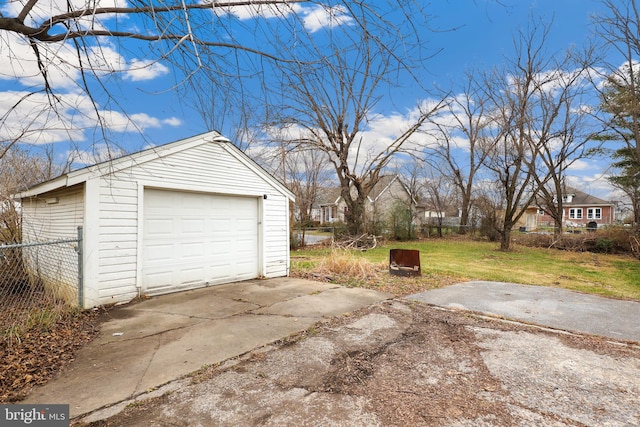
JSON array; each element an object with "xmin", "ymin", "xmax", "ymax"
[{"xmin": 291, "ymin": 239, "xmax": 640, "ymax": 300}]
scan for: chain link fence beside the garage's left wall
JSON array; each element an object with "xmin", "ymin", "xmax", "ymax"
[{"xmin": 0, "ymin": 236, "xmax": 82, "ymax": 342}]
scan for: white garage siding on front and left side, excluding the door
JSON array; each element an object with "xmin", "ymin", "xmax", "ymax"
[{"xmin": 23, "ymin": 137, "xmax": 289, "ymax": 307}]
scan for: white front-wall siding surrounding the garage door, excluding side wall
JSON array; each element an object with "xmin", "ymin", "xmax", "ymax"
[{"xmin": 92, "ymin": 143, "xmax": 289, "ymax": 304}]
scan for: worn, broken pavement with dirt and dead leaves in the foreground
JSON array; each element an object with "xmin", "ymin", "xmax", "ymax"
[{"xmin": 77, "ymin": 300, "xmax": 640, "ymax": 426}]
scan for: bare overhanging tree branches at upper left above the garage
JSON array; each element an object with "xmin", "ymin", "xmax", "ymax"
[{"xmin": 0, "ymin": 0, "xmax": 436, "ymax": 162}]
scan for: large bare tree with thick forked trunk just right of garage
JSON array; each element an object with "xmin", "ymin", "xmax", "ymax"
[{"xmin": 273, "ymin": 23, "xmax": 444, "ymax": 235}]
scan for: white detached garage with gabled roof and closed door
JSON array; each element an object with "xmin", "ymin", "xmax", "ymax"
[{"xmin": 21, "ymin": 132, "xmax": 293, "ymax": 307}]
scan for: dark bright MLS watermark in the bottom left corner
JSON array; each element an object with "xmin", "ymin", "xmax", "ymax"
[{"xmin": 0, "ymin": 405, "xmax": 70, "ymax": 427}]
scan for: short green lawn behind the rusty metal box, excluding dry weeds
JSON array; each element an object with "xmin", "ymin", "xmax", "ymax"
[{"xmin": 291, "ymin": 239, "xmax": 640, "ymax": 300}]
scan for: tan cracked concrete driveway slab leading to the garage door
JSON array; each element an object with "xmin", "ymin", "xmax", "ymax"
[{"xmin": 23, "ymin": 278, "xmax": 390, "ymax": 418}]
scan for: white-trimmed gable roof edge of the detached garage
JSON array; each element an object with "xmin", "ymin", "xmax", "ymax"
[{"xmin": 17, "ymin": 131, "xmax": 295, "ymax": 200}]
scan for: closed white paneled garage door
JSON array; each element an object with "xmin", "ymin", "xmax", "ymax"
[{"xmin": 142, "ymin": 189, "xmax": 259, "ymax": 295}]
